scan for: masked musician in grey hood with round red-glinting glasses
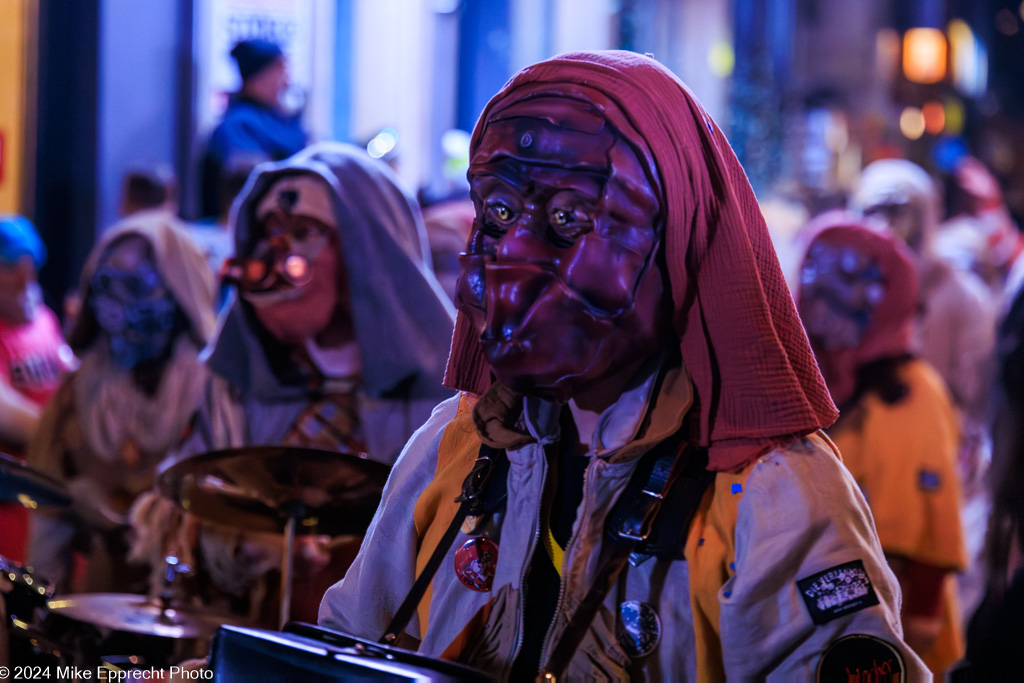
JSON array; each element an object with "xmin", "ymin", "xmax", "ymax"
[{"xmin": 162, "ymin": 143, "xmax": 454, "ymax": 623}]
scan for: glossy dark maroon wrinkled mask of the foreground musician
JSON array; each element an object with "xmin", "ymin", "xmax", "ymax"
[{"xmin": 456, "ymin": 96, "xmax": 670, "ymax": 402}]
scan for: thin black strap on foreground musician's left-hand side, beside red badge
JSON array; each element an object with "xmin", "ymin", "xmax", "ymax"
[{"xmin": 379, "ymin": 444, "xmax": 508, "ymax": 645}]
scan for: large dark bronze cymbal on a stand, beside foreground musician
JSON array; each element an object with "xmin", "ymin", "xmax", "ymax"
[{"xmin": 157, "ymin": 445, "xmax": 390, "ymax": 536}]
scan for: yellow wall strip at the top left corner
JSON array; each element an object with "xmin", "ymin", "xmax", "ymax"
[{"xmin": 0, "ymin": 0, "xmax": 31, "ymax": 213}]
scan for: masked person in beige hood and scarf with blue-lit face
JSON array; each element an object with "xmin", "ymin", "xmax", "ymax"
[{"xmin": 28, "ymin": 211, "xmax": 214, "ymax": 592}]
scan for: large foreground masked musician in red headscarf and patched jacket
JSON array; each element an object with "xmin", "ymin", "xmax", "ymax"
[{"xmin": 319, "ymin": 52, "xmax": 927, "ymax": 680}]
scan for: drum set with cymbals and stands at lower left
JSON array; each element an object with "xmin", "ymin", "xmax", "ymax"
[{"xmin": 0, "ymin": 446, "xmax": 407, "ymax": 672}]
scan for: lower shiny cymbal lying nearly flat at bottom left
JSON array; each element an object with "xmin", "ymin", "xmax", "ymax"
[{"xmin": 47, "ymin": 593, "xmax": 237, "ymax": 638}]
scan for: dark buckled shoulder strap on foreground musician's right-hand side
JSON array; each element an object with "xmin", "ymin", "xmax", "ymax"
[{"xmin": 541, "ymin": 438, "xmax": 689, "ymax": 680}]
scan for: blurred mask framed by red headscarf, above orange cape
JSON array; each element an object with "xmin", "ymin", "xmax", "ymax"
[{"xmin": 800, "ymin": 242, "xmax": 886, "ymax": 351}]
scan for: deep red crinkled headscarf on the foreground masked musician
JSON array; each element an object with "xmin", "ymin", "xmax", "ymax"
[{"xmin": 444, "ymin": 51, "xmax": 838, "ymax": 471}]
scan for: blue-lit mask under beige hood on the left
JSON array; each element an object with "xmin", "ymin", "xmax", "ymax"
[{"xmin": 89, "ymin": 237, "xmax": 177, "ymax": 370}]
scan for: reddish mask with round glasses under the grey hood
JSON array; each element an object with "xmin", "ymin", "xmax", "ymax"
[{"xmin": 225, "ymin": 174, "xmax": 348, "ymax": 345}]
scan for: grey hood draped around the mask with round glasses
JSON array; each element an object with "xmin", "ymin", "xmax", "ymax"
[{"xmin": 208, "ymin": 142, "xmax": 455, "ymax": 400}]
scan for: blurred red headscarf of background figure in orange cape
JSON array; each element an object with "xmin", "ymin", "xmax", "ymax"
[{"xmin": 798, "ymin": 211, "xmax": 918, "ymax": 404}]
